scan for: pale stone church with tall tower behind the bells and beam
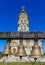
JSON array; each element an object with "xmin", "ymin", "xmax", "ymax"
[{"xmin": 4, "ymin": 8, "xmax": 42, "ymax": 62}]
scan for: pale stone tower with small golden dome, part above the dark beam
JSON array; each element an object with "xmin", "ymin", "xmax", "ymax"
[{"xmin": 18, "ymin": 7, "xmax": 29, "ymax": 32}]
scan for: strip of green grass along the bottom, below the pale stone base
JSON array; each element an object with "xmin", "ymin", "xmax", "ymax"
[{"xmin": 0, "ymin": 62, "xmax": 45, "ymax": 65}]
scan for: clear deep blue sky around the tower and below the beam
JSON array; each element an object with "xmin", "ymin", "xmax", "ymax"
[{"xmin": 0, "ymin": 0, "xmax": 45, "ymax": 52}]
